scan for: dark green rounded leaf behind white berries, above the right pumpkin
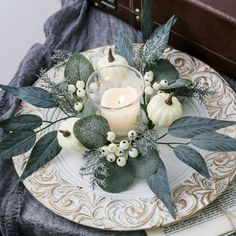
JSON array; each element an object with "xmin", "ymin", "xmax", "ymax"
[{"xmin": 145, "ymin": 59, "xmax": 179, "ymax": 83}]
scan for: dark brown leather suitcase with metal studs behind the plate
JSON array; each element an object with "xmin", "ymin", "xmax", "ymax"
[{"xmin": 90, "ymin": 0, "xmax": 236, "ymax": 77}]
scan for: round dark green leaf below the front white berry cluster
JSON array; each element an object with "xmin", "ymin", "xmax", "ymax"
[{"xmin": 95, "ymin": 160, "xmax": 135, "ymax": 193}]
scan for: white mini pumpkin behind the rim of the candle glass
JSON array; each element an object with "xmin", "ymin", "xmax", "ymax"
[{"xmin": 96, "ymin": 48, "xmax": 129, "ymax": 81}]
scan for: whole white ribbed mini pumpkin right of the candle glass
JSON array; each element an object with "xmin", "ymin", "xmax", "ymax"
[{"xmin": 147, "ymin": 93, "xmax": 182, "ymax": 127}]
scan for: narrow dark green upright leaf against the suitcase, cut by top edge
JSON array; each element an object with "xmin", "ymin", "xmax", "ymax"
[{"xmin": 141, "ymin": 0, "xmax": 153, "ymax": 41}]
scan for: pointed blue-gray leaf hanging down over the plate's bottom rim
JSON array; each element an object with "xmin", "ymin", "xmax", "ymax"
[{"xmin": 147, "ymin": 160, "xmax": 175, "ymax": 218}]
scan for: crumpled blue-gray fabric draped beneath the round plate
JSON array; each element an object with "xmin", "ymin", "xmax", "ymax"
[{"xmin": 0, "ymin": 0, "xmax": 236, "ymax": 236}]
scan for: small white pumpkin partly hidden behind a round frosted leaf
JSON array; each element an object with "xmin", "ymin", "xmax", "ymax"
[{"xmin": 57, "ymin": 117, "xmax": 85, "ymax": 152}]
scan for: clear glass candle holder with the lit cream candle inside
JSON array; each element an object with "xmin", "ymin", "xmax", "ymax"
[{"xmin": 86, "ymin": 65, "xmax": 145, "ymax": 137}]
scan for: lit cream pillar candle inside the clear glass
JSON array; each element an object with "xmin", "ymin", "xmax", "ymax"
[{"xmin": 101, "ymin": 87, "xmax": 140, "ymax": 136}]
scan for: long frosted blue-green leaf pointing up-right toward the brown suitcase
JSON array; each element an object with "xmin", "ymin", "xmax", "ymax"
[{"xmin": 142, "ymin": 16, "xmax": 176, "ymax": 64}]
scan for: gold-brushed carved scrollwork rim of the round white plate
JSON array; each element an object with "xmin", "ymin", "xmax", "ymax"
[{"xmin": 13, "ymin": 47, "xmax": 236, "ymax": 230}]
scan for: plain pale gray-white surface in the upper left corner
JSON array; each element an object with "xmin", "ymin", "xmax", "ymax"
[{"xmin": 0, "ymin": 0, "xmax": 61, "ymax": 84}]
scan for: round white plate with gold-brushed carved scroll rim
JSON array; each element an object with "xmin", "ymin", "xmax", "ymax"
[{"xmin": 13, "ymin": 47, "xmax": 236, "ymax": 230}]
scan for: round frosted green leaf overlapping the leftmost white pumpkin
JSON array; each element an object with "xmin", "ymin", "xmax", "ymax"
[{"xmin": 74, "ymin": 115, "xmax": 110, "ymax": 149}]
